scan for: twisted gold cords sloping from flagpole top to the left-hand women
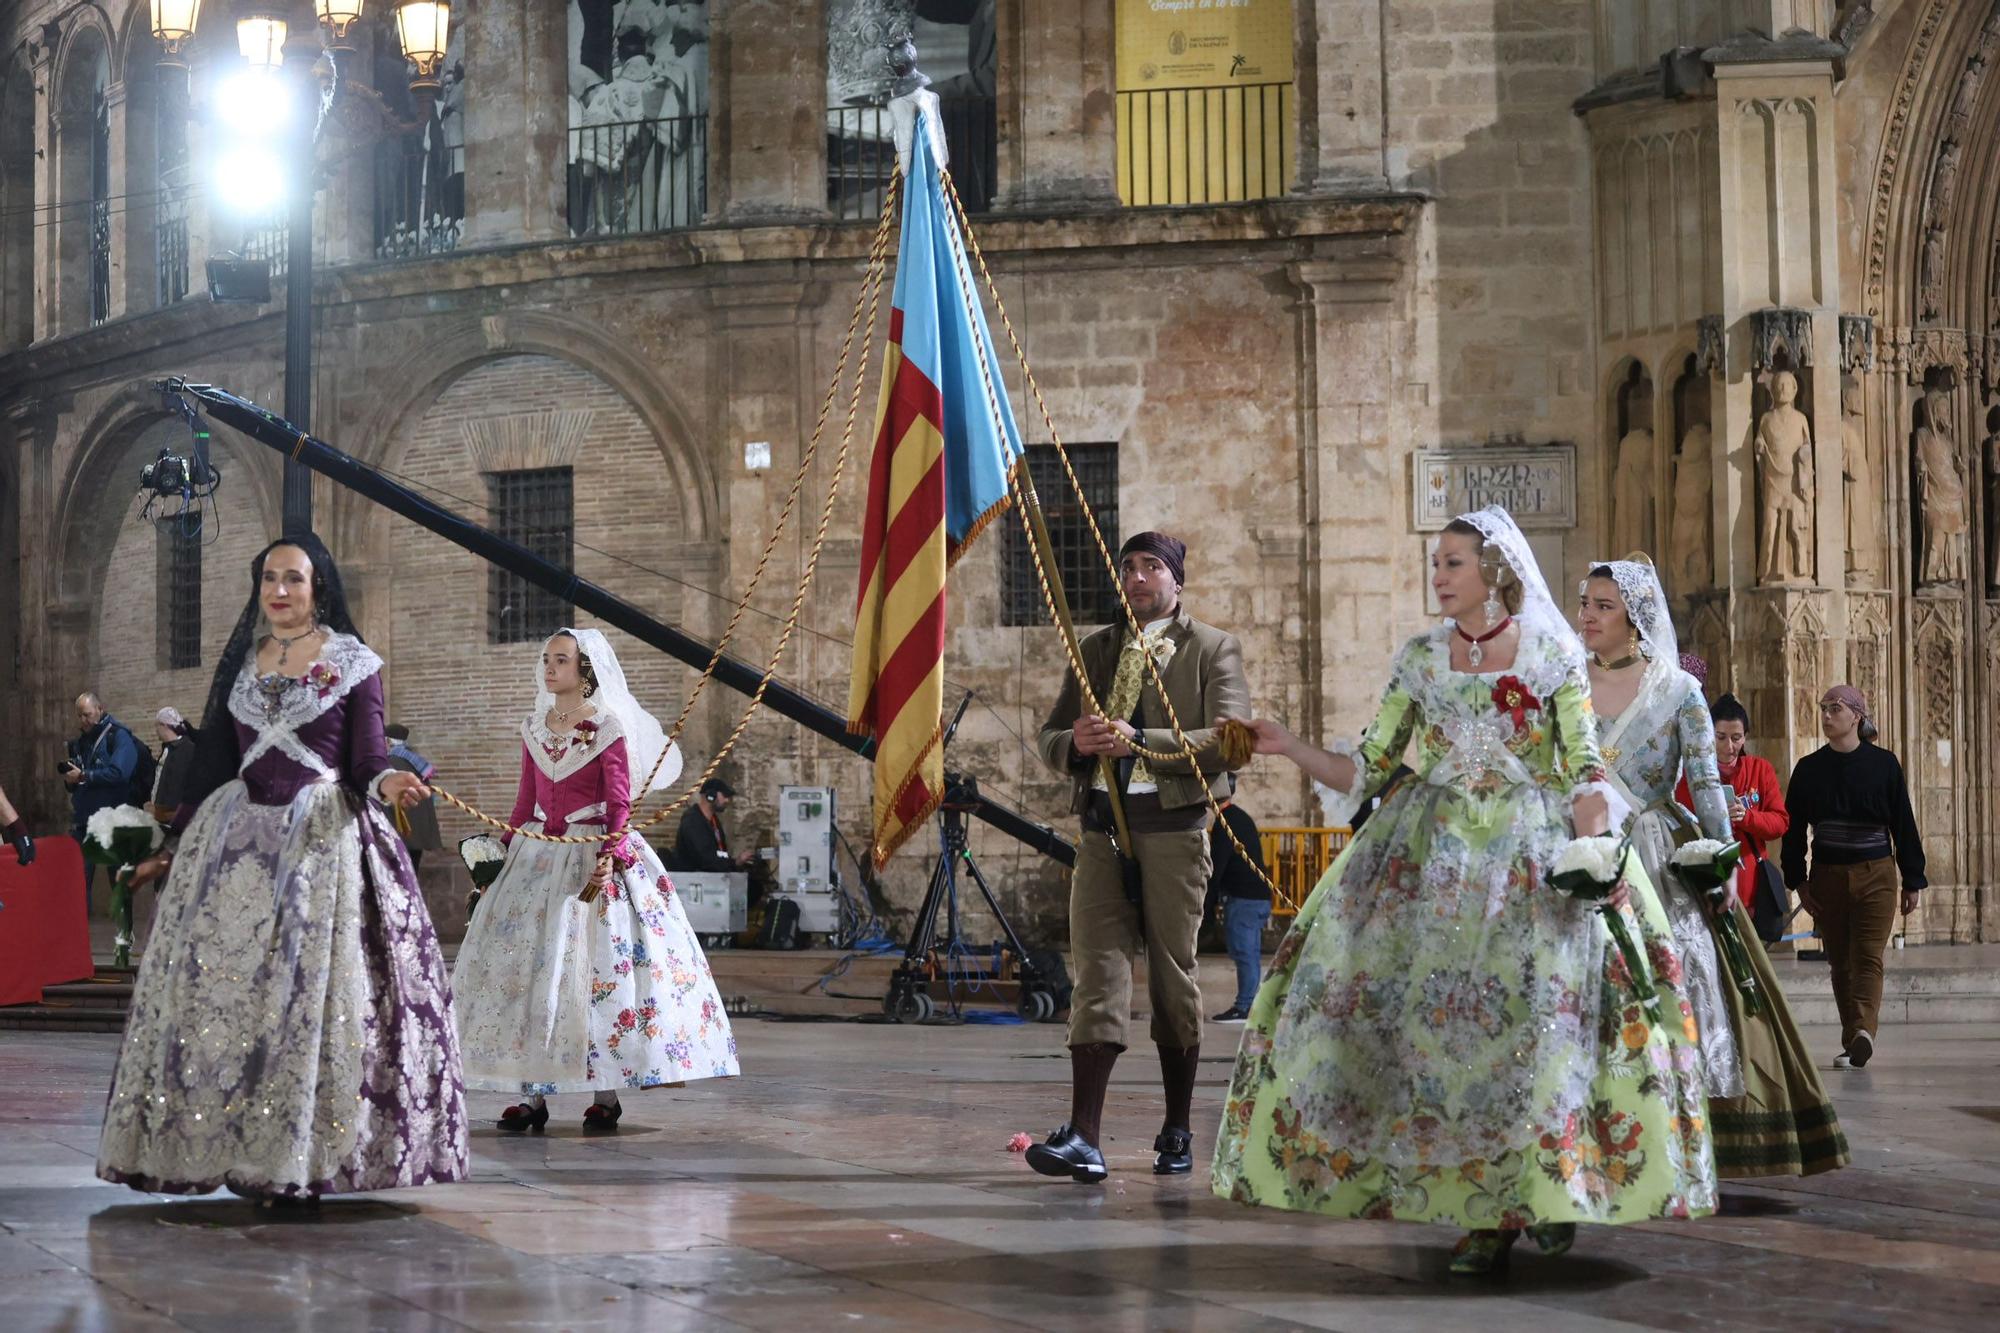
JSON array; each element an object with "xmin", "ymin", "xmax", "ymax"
[{"xmin": 430, "ymin": 174, "xmax": 902, "ymax": 847}]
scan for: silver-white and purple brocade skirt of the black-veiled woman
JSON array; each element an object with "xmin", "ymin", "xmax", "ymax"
[{"xmin": 98, "ymin": 783, "xmax": 466, "ymax": 1195}]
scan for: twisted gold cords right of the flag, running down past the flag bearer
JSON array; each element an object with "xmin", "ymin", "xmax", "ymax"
[{"xmin": 938, "ymin": 168, "xmax": 1278, "ymax": 893}]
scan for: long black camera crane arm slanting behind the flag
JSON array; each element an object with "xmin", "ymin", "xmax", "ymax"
[{"xmin": 160, "ymin": 378, "xmax": 1076, "ymax": 865}]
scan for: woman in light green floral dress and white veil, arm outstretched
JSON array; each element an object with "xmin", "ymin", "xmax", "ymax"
[{"xmin": 1214, "ymin": 508, "xmax": 1716, "ymax": 1273}]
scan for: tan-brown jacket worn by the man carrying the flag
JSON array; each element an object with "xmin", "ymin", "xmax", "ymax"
[{"xmin": 1038, "ymin": 608, "xmax": 1250, "ymax": 815}]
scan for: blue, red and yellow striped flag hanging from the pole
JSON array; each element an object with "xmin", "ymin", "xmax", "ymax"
[{"xmin": 848, "ymin": 114, "xmax": 1022, "ymax": 867}]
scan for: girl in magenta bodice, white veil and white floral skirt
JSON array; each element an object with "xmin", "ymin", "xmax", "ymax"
[{"xmin": 452, "ymin": 628, "xmax": 738, "ymax": 1131}]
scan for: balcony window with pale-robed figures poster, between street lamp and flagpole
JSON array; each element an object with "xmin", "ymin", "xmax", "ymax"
[{"xmin": 568, "ymin": 0, "xmax": 708, "ymax": 236}]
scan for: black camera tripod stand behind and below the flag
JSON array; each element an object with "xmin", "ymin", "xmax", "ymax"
[{"xmin": 882, "ymin": 693, "xmax": 1056, "ymax": 1023}]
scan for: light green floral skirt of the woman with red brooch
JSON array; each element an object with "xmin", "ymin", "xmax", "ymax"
[{"xmin": 1212, "ymin": 783, "xmax": 1716, "ymax": 1227}]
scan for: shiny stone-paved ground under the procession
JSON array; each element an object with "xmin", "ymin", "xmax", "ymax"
[{"xmin": 0, "ymin": 1021, "xmax": 2000, "ymax": 1333}]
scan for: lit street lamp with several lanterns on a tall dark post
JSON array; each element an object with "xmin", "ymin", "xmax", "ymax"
[{"xmin": 152, "ymin": 0, "xmax": 452, "ymax": 534}]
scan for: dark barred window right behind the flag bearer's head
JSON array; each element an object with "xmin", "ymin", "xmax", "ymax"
[{"xmin": 1000, "ymin": 444, "xmax": 1122, "ymax": 624}]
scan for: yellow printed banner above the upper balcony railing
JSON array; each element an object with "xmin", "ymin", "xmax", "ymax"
[{"xmin": 1118, "ymin": 0, "xmax": 1296, "ymax": 92}]
